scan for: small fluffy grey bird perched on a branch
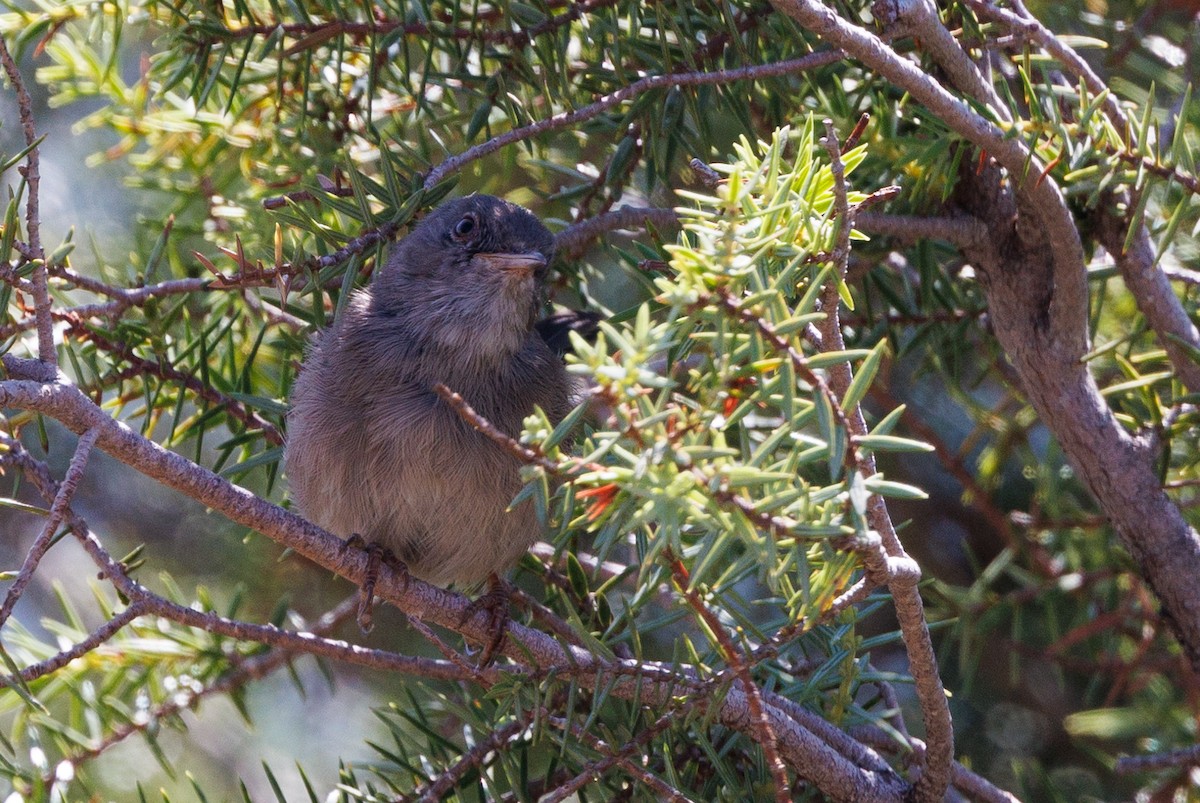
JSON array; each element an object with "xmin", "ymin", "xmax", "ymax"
[{"xmin": 286, "ymin": 196, "xmax": 580, "ymax": 607}]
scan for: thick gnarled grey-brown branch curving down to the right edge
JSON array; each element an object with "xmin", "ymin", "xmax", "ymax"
[{"xmin": 773, "ymin": 0, "xmax": 1200, "ymax": 669}]
